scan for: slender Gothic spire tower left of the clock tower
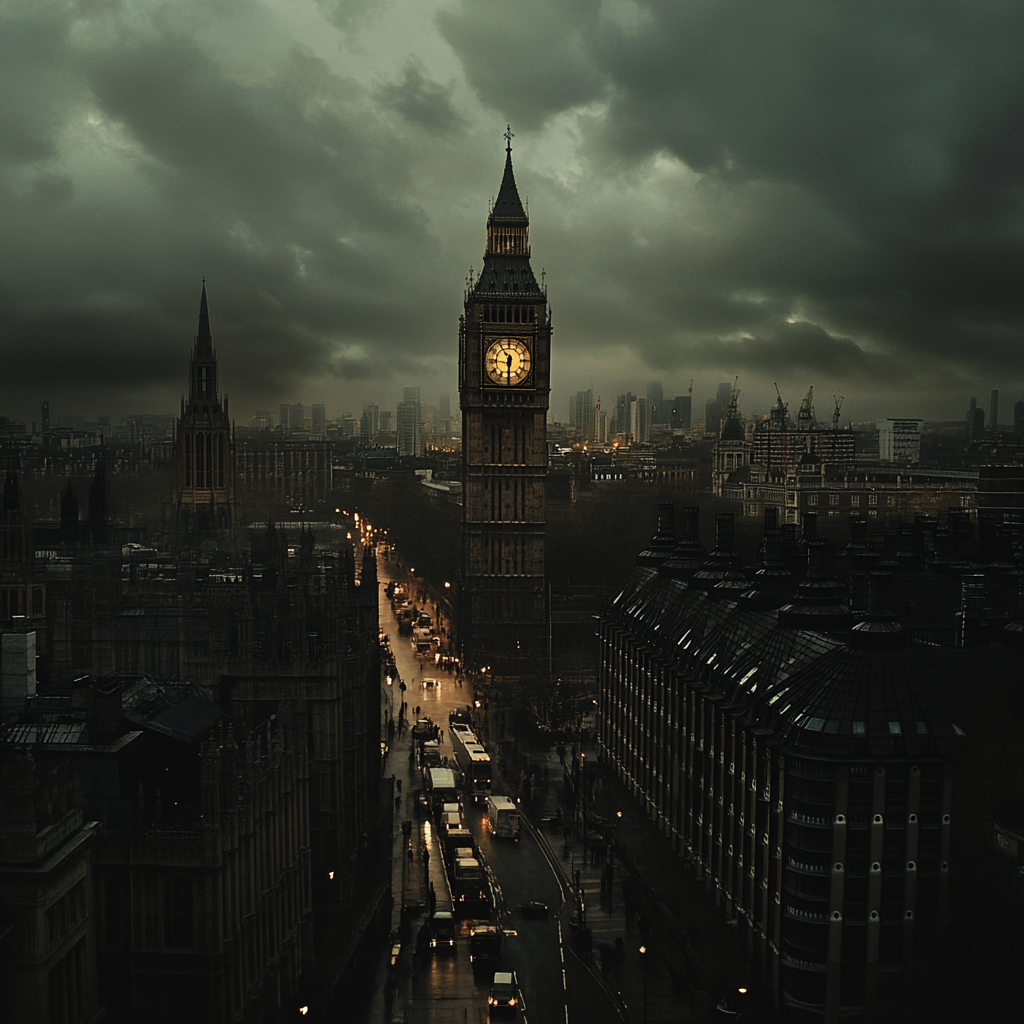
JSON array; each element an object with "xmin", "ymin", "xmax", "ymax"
[{"xmin": 172, "ymin": 281, "xmax": 234, "ymax": 542}]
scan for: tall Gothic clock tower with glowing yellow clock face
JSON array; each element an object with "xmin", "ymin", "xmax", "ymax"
[{"xmin": 459, "ymin": 131, "xmax": 551, "ymax": 682}]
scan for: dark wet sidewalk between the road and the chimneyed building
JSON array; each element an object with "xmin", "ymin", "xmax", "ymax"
[{"xmin": 479, "ymin": 715, "xmax": 754, "ymax": 1024}]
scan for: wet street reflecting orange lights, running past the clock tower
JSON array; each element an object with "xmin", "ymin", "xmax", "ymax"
[{"xmin": 346, "ymin": 558, "xmax": 622, "ymax": 1024}]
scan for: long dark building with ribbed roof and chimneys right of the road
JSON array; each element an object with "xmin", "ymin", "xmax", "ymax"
[{"xmin": 599, "ymin": 506, "xmax": 1019, "ymax": 1024}]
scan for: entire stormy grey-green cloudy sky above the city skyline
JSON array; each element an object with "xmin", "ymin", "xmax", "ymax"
[{"xmin": 0, "ymin": 0, "xmax": 1024, "ymax": 422}]
